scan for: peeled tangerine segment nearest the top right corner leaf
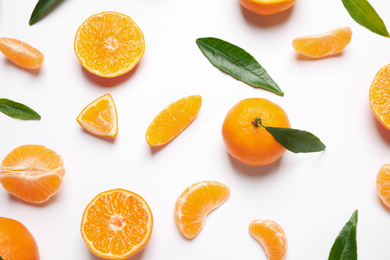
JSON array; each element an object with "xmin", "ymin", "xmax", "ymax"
[{"xmin": 292, "ymin": 27, "xmax": 352, "ymax": 58}]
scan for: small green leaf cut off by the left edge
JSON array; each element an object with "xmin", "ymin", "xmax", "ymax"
[{"xmin": 0, "ymin": 98, "xmax": 41, "ymax": 119}]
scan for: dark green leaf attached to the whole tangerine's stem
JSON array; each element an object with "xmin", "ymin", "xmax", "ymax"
[{"xmin": 264, "ymin": 126, "xmax": 326, "ymax": 153}]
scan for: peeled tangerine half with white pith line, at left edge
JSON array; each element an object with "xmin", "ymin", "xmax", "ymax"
[{"xmin": 0, "ymin": 144, "xmax": 65, "ymax": 203}]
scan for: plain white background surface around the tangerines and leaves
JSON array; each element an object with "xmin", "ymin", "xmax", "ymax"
[{"xmin": 0, "ymin": 0, "xmax": 390, "ymax": 260}]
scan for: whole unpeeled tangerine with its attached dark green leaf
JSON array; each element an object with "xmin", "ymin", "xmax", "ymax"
[{"xmin": 222, "ymin": 98, "xmax": 325, "ymax": 166}]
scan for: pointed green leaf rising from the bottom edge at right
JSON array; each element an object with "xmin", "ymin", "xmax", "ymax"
[{"xmin": 328, "ymin": 210, "xmax": 358, "ymax": 260}]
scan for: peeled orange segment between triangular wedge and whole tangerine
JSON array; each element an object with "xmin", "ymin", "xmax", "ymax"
[{"xmin": 145, "ymin": 95, "xmax": 202, "ymax": 146}]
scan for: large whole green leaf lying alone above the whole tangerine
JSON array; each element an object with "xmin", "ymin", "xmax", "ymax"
[{"xmin": 196, "ymin": 37, "xmax": 284, "ymax": 96}]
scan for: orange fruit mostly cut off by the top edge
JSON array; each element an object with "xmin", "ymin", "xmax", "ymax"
[{"xmin": 240, "ymin": 0, "xmax": 296, "ymax": 15}]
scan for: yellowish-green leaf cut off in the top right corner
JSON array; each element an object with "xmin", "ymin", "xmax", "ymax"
[{"xmin": 341, "ymin": 0, "xmax": 390, "ymax": 37}]
